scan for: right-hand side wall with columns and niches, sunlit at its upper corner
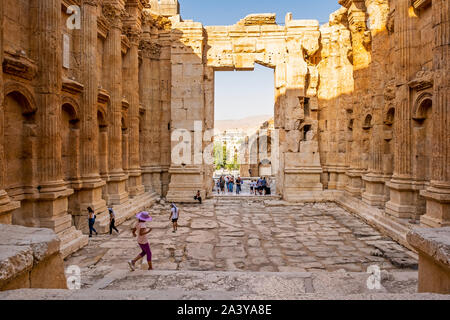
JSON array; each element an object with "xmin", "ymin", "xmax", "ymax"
[{"xmin": 319, "ymin": 0, "xmax": 450, "ymax": 227}]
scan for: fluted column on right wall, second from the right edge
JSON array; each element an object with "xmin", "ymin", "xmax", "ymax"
[{"xmin": 386, "ymin": 1, "xmax": 418, "ymax": 218}]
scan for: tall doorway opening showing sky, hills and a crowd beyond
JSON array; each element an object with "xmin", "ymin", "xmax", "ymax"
[{"xmin": 214, "ymin": 64, "xmax": 276, "ymax": 196}]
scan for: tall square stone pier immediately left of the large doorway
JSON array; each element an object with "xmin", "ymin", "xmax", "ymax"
[{"xmin": 167, "ymin": 22, "xmax": 206, "ymax": 202}]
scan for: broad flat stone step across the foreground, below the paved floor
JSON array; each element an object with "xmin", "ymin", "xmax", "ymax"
[{"xmin": 0, "ymin": 269, "xmax": 450, "ymax": 300}]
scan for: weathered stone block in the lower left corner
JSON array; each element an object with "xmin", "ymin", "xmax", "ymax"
[{"xmin": 0, "ymin": 225, "xmax": 67, "ymax": 290}]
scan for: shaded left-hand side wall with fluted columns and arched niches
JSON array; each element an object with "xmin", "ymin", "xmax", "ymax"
[{"xmin": 0, "ymin": 0, "xmax": 178, "ymax": 255}]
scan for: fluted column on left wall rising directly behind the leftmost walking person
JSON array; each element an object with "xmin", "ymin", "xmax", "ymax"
[{"xmin": 78, "ymin": 0, "xmax": 106, "ymax": 217}]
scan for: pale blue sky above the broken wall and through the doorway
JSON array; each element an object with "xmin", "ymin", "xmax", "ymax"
[{"xmin": 179, "ymin": 0, "xmax": 340, "ymax": 120}]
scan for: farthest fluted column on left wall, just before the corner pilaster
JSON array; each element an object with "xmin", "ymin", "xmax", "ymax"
[{"xmin": 123, "ymin": 0, "xmax": 145, "ymax": 197}]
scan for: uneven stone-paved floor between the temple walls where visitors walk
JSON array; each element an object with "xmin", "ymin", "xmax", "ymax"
[{"xmin": 66, "ymin": 199, "xmax": 417, "ymax": 287}]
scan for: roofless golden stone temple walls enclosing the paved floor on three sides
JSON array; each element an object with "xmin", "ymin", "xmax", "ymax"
[{"xmin": 0, "ymin": 0, "xmax": 450, "ymax": 296}]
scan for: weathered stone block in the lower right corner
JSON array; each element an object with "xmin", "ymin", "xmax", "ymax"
[{"xmin": 408, "ymin": 227, "xmax": 450, "ymax": 294}]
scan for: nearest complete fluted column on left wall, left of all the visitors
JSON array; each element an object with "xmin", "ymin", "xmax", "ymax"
[{"xmin": 32, "ymin": 0, "xmax": 73, "ymax": 232}]
